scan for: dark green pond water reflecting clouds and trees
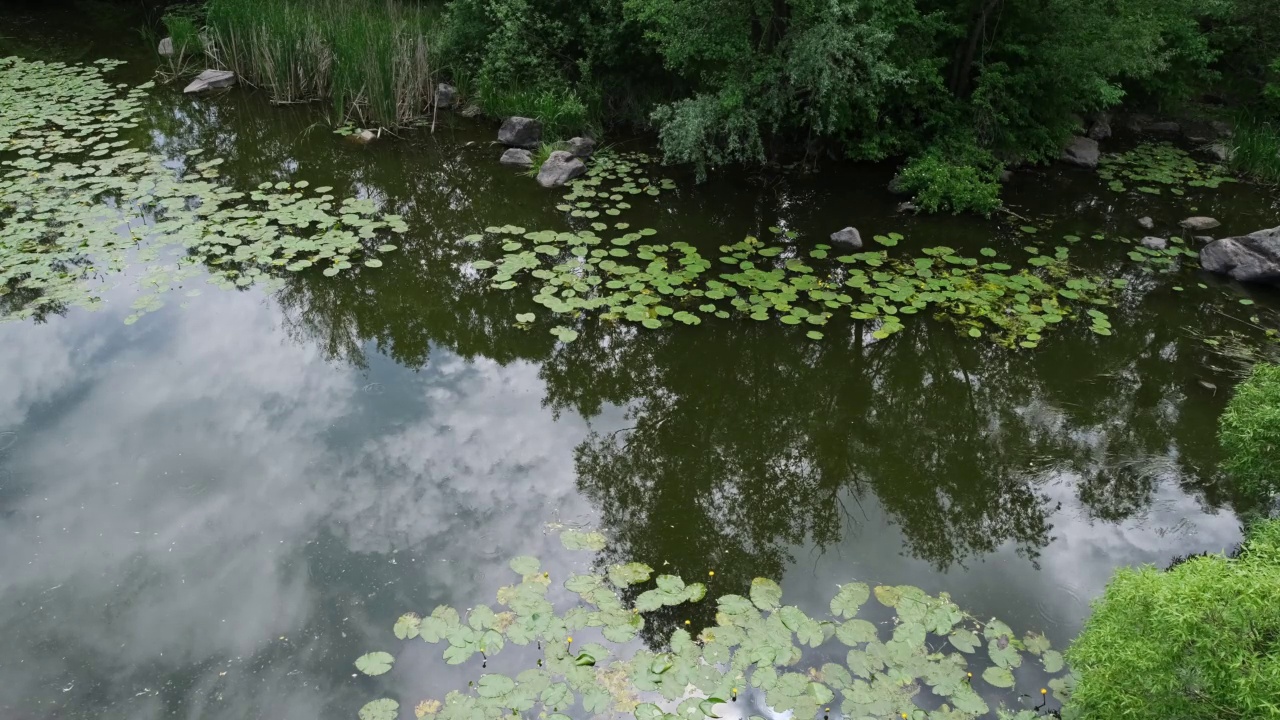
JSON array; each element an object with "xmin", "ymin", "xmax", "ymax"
[{"xmin": 0, "ymin": 2, "xmax": 1277, "ymax": 720}]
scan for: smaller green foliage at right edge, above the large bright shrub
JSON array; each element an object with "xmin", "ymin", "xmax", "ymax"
[{"xmin": 1219, "ymin": 364, "xmax": 1280, "ymax": 496}]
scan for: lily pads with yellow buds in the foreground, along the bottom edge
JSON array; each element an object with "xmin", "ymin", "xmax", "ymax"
[{"xmin": 356, "ymin": 527, "xmax": 1074, "ymax": 720}]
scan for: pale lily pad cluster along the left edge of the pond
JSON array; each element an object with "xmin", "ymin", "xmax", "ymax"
[{"xmin": 0, "ymin": 58, "xmax": 407, "ymax": 322}]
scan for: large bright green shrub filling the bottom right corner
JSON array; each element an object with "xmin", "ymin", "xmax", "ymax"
[{"xmin": 1066, "ymin": 520, "xmax": 1280, "ymax": 720}]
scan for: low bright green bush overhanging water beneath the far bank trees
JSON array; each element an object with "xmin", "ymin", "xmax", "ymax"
[{"xmin": 897, "ymin": 141, "xmax": 1004, "ymax": 215}]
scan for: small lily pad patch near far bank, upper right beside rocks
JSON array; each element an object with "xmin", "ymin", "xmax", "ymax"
[{"xmin": 1098, "ymin": 142, "xmax": 1236, "ymax": 195}]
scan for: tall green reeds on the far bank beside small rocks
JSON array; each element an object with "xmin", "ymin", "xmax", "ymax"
[{"xmin": 206, "ymin": 0, "xmax": 440, "ymax": 126}]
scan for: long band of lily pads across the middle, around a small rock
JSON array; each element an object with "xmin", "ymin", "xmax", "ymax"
[{"xmin": 465, "ymin": 213, "xmax": 1112, "ymax": 347}]
